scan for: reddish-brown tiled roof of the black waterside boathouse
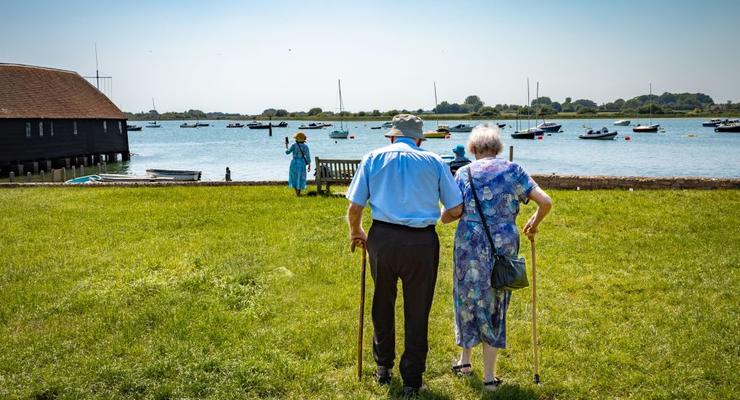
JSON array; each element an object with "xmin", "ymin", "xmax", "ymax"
[{"xmin": 0, "ymin": 63, "xmax": 125, "ymax": 119}]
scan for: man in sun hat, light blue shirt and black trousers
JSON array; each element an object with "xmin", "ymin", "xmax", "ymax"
[{"xmin": 347, "ymin": 114, "xmax": 463, "ymax": 395}]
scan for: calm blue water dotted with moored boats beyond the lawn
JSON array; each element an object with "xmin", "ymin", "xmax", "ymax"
[{"xmin": 124, "ymin": 119, "xmax": 740, "ymax": 181}]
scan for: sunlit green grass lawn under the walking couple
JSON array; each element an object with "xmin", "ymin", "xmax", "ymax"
[{"xmin": 0, "ymin": 187, "xmax": 740, "ymax": 399}]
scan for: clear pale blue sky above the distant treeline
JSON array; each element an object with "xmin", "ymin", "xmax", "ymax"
[{"xmin": 0, "ymin": 0, "xmax": 740, "ymax": 114}]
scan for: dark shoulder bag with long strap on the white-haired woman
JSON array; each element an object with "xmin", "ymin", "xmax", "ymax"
[{"xmin": 468, "ymin": 168, "xmax": 529, "ymax": 290}]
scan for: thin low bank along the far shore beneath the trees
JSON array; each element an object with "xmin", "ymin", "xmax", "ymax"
[{"xmin": 128, "ymin": 112, "xmax": 740, "ymax": 122}]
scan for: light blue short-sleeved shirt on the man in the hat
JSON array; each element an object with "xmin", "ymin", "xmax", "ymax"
[{"xmin": 347, "ymin": 137, "xmax": 463, "ymax": 228}]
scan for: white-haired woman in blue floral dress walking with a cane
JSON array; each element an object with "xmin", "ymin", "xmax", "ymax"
[{"xmin": 443, "ymin": 125, "xmax": 552, "ymax": 390}]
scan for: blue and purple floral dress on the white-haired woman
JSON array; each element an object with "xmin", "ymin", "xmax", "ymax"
[{"xmin": 453, "ymin": 157, "xmax": 537, "ymax": 348}]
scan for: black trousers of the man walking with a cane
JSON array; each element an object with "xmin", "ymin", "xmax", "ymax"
[{"xmin": 367, "ymin": 221, "xmax": 439, "ymax": 388}]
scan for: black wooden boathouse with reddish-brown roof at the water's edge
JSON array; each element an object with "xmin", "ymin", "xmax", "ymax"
[{"xmin": 0, "ymin": 63, "xmax": 129, "ymax": 174}]
